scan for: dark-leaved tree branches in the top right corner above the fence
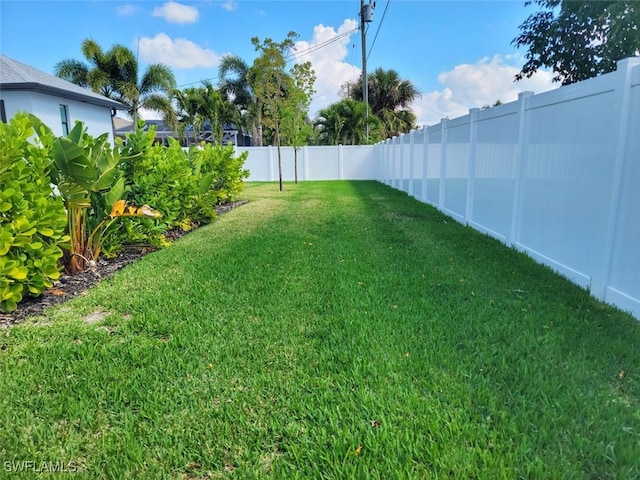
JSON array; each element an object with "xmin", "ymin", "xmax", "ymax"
[{"xmin": 511, "ymin": 0, "xmax": 640, "ymax": 85}]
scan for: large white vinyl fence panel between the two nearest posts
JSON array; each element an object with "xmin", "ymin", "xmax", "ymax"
[{"xmin": 516, "ymin": 76, "xmax": 617, "ymax": 287}]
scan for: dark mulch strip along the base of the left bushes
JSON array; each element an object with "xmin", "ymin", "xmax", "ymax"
[{"xmin": 0, "ymin": 201, "xmax": 247, "ymax": 329}]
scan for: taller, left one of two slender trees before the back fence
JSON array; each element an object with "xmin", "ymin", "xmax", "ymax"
[{"xmin": 251, "ymin": 32, "xmax": 298, "ymax": 191}]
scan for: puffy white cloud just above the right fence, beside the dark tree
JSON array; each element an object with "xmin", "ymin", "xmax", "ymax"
[{"xmin": 413, "ymin": 55, "xmax": 558, "ymax": 125}]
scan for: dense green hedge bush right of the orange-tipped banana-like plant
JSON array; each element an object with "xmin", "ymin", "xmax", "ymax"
[{"xmin": 120, "ymin": 127, "xmax": 249, "ymax": 246}]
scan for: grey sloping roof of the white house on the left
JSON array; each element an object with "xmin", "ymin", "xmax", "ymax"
[{"xmin": 0, "ymin": 55, "xmax": 127, "ymax": 110}]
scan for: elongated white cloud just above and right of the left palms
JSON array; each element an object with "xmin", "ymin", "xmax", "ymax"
[{"xmin": 140, "ymin": 33, "xmax": 220, "ymax": 68}]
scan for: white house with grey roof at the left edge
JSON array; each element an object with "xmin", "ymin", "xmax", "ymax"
[{"xmin": 0, "ymin": 55, "xmax": 126, "ymax": 143}]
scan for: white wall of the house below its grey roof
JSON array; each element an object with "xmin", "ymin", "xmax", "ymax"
[{"xmin": 0, "ymin": 90, "xmax": 113, "ymax": 144}]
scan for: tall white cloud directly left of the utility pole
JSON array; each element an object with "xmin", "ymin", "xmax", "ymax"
[{"xmin": 293, "ymin": 19, "xmax": 361, "ymax": 117}]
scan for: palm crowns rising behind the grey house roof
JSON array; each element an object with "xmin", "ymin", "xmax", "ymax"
[{"xmin": 55, "ymin": 39, "xmax": 176, "ymax": 129}]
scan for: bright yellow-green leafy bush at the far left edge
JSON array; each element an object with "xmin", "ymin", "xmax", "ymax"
[{"xmin": 0, "ymin": 114, "xmax": 69, "ymax": 312}]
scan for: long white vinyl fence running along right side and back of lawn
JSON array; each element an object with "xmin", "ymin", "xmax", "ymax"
[{"xmin": 238, "ymin": 58, "xmax": 640, "ymax": 319}]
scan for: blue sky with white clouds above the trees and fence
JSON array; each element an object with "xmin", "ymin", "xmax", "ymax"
[{"xmin": 0, "ymin": 0, "xmax": 557, "ymax": 125}]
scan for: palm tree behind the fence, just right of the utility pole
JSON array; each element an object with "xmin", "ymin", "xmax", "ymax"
[{"xmin": 349, "ymin": 68, "xmax": 420, "ymax": 138}]
